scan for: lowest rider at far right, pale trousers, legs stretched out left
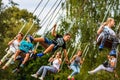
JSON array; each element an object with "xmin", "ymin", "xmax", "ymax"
[{"xmin": 88, "ymin": 54, "xmax": 118, "ymax": 77}]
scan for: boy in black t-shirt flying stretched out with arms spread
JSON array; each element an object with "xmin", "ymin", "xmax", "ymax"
[{"xmin": 30, "ymin": 24, "xmax": 71, "ymax": 62}]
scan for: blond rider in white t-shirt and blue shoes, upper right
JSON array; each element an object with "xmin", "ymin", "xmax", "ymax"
[{"xmin": 97, "ymin": 18, "xmax": 119, "ymax": 54}]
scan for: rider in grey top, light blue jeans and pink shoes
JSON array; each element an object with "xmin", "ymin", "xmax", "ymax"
[{"xmin": 68, "ymin": 50, "xmax": 84, "ymax": 80}]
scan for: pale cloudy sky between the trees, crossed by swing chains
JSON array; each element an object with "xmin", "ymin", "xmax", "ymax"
[{"xmin": 2, "ymin": 0, "xmax": 65, "ymax": 35}]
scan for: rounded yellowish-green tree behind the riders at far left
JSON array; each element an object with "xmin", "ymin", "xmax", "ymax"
[{"xmin": 0, "ymin": 3, "xmax": 39, "ymax": 80}]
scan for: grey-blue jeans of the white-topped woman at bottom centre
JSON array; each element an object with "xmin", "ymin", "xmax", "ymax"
[{"xmin": 37, "ymin": 66, "xmax": 57, "ymax": 77}]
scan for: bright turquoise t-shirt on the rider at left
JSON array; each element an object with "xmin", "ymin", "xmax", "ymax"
[{"xmin": 19, "ymin": 40, "xmax": 33, "ymax": 53}]
